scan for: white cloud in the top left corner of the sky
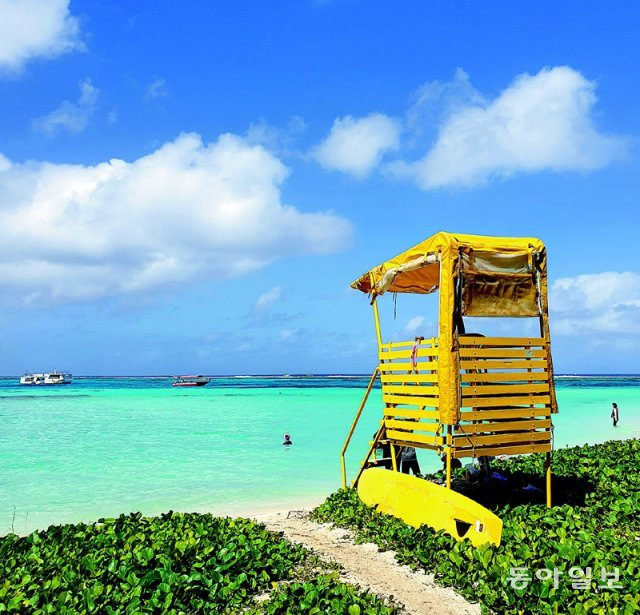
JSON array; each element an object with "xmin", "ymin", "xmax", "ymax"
[{"xmin": 0, "ymin": 0, "xmax": 83, "ymax": 72}]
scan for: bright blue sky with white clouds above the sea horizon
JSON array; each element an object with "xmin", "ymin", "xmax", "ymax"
[{"xmin": 0, "ymin": 0, "xmax": 640, "ymax": 375}]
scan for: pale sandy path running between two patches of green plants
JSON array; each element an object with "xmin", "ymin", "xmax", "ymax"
[{"xmin": 255, "ymin": 511, "xmax": 480, "ymax": 615}]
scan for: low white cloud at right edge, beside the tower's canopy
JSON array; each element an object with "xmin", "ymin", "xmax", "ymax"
[{"xmin": 549, "ymin": 271, "xmax": 640, "ymax": 335}]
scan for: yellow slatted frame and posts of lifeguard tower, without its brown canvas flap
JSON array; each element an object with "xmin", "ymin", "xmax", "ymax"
[{"xmin": 341, "ymin": 233, "xmax": 557, "ymax": 506}]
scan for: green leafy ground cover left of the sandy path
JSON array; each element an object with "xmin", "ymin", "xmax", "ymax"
[{"xmin": 0, "ymin": 512, "xmax": 394, "ymax": 615}]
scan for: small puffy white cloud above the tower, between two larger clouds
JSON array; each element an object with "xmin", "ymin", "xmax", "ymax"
[{"xmin": 313, "ymin": 113, "xmax": 400, "ymax": 179}]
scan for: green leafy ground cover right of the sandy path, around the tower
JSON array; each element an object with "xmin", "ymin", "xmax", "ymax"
[{"xmin": 312, "ymin": 440, "xmax": 640, "ymax": 615}]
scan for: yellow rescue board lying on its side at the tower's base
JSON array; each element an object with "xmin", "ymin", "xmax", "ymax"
[{"xmin": 358, "ymin": 468, "xmax": 502, "ymax": 547}]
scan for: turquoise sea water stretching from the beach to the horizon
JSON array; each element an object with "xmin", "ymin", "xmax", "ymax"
[{"xmin": 0, "ymin": 376, "xmax": 640, "ymax": 534}]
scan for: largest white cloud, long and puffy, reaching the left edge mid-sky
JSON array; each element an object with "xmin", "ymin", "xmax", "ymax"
[{"xmin": 0, "ymin": 134, "xmax": 352, "ymax": 302}]
